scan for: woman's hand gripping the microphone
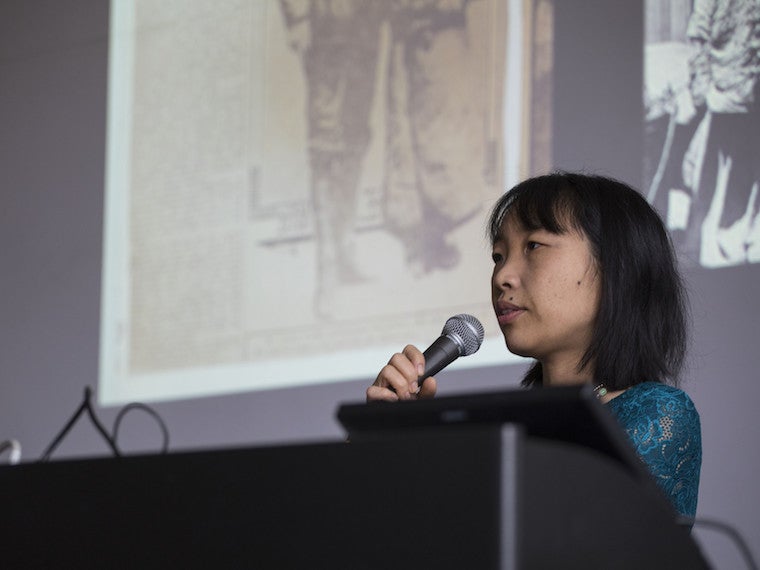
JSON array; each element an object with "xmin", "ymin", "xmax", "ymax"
[{"xmin": 367, "ymin": 344, "xmax": 436, "ymax": 402}]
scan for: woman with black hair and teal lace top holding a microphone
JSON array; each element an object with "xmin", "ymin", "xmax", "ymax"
[{"xmin": 367, "ymin": 173, "xmax": 702, "ymax": 518}]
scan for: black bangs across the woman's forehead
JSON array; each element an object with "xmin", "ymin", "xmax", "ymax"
[{"xmin": 488, "ymin": 175, "xmax": 583, "ymax": 244}]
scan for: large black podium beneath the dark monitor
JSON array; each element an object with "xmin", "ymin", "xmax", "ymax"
[{"xmin": 0, "ymin": 388, "xmax": 707, "ymax": 570}]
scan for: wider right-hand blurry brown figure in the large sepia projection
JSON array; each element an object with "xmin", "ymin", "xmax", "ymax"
[{"xmin": 383, "ymin": 0, "xmax": 503, "ymax": 274}]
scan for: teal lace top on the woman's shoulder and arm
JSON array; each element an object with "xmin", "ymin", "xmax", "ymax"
[{"xmin": 606, "ymin": 382, "xmax": 702, "ymax": 519}]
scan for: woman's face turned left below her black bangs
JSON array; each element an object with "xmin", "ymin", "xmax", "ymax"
[{"xmin": 491, "ymin": 211, "xmax": 601, "ymax": 366}]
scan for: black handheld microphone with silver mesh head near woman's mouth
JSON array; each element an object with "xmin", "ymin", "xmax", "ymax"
[{"xmin": 417, "ymin": 314, "xmax": 484, "ymax": 385}]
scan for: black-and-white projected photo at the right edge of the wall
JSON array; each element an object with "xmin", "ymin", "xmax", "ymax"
[{"xmin": 644, "ymin": 0, "xmax": 760, "ymax": 267}]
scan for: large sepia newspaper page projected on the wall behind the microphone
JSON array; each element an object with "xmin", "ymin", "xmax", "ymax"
[{"xmin": 101, "ymin": 0, "xmax": 551, "ymax": 403}]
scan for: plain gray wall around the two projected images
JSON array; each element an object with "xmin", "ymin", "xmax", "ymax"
[{"xmin": 0, "ymin": 0, "xmax": 760, "ymax": 568}]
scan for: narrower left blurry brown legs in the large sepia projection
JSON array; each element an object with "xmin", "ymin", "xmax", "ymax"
[{"xmin": 282, "ymin": 0, "xmax": 382, "ymax": 315}]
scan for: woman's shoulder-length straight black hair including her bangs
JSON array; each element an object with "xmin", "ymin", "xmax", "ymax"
[{"xmin": 488, "ymin": 172, "xmax": 689, "ymax": 390}]
